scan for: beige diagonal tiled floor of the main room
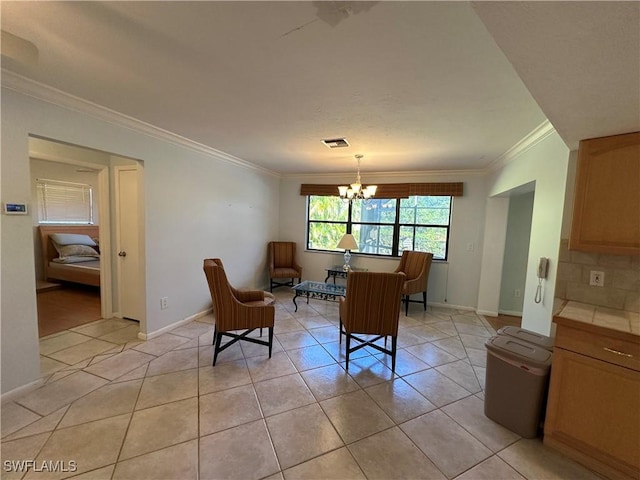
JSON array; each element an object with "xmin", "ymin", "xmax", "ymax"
[{"xmin": 2, "ymin": 289, "xmax": 599, "ymax": 480}]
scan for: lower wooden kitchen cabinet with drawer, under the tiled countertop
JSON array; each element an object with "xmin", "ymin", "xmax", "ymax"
[{"xmin": 544, "ymin": 317, "xmax": 640, "ymax": 479}]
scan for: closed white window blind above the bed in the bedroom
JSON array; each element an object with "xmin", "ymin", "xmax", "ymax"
[{"xmin": 36, "ymin": 178, "xmax": 93, "ymax": 224}]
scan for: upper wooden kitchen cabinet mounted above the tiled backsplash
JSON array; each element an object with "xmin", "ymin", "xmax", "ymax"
[{"xmin": 569, "ymin": 132, "xmax": 640, "ymax": 255}]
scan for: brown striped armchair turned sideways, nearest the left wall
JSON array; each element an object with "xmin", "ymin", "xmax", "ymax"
[{"xmin": 203, "ymin": 258, "xmax": 275, "ymax": 366}]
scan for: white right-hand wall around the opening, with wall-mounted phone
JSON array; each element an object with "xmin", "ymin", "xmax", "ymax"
[{"xmin": 478, "ymin": 132, "xmax": 569, "ymax": 335}]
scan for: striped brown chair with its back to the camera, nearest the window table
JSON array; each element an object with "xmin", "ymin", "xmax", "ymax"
[{"xmin": 340, "ymin": 271, "xmax": 405, "ymax": 372}]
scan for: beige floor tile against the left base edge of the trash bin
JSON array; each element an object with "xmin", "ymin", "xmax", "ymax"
[{"xmin": 442, "ymin": 395, "xmax": 520, "ymax": 452}]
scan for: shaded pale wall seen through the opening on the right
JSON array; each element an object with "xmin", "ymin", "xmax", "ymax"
[{"xmin": 499, "ymin": 192, "xmax": 534, "ymax": 315}]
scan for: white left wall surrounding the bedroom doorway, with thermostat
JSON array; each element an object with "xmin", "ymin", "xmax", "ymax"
[{"xmin": 0, "ymin": 88, "xmax": 279, "ymax": 392}]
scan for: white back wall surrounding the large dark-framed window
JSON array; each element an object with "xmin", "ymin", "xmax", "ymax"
[{"xmin": 279, "ymin": 172, "xmax": 486, "ymax": 309}]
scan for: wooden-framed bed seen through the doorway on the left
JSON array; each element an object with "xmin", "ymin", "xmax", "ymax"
[{"xmin": 38, "ymin": 225, "xmax": 100, "ymax": 287}]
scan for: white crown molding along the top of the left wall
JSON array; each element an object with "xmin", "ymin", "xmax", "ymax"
[{"xmin": 1, "ymin": 68, "xmax": 281, "ymax": 178}]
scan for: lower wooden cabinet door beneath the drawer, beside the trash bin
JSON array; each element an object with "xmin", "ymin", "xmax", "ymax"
[{"xmin": 545, "ymin": 348, "xmax": 640, "ymax": 478}]
